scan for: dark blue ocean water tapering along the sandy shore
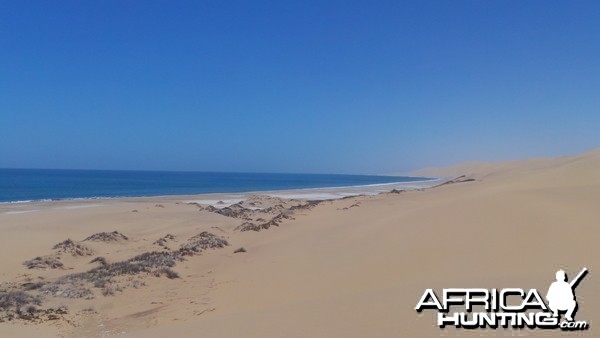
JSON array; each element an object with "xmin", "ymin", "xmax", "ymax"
[{"xmin": 0, "ymin": 169, "xmax": 428, "ymax": 203}]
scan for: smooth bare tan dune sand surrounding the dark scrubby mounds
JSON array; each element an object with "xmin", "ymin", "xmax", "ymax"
[{"xmin": 0, "ymin": 151, "xmax": 600, "ymax": 337}]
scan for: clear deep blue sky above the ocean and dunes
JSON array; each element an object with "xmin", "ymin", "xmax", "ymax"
[{"xmin": 0, "ymin": 0, "xmax": 600, "ymax": 173}]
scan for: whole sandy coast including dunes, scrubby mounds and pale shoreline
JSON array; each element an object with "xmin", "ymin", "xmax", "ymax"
[{"xmin": 0, "ymin": 150, "xmax": 600, "ymax": 338}]
